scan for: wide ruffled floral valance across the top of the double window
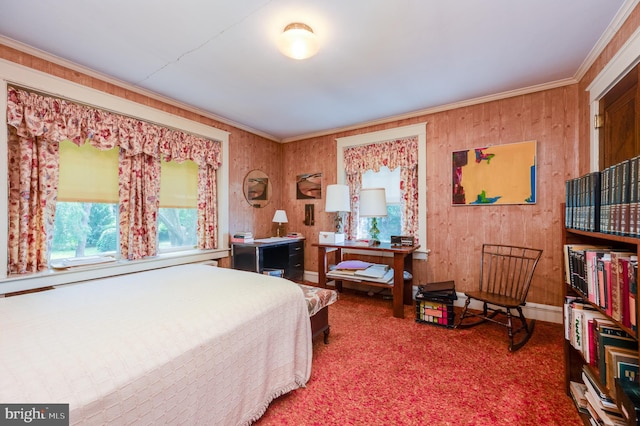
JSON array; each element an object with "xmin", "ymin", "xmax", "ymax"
[{"xmin": 7, "ymin": 87, "xmax": 222, "ymax": 169}]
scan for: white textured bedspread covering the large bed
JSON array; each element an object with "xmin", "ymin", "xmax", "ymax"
[{"xmin": 0, "ymin": 265, "xmax": 312, "ymax": 425}]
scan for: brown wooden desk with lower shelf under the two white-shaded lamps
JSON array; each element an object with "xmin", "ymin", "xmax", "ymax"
[{"xmin": 312, "ymin": 241, "xmax": 420, "ymax": 318}]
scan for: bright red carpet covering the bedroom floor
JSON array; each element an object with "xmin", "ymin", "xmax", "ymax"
[{"xmin": 256, "ymin": 290, "xmax": 582, "ymax": 426}]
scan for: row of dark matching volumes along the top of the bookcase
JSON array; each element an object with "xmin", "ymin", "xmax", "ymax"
[{"xmin": 565, "ymin": 156, "xmax": 640, "ymax": 237}]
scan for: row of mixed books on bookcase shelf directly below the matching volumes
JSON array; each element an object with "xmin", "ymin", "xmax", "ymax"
[{"xmin": 564, "ymin": 244, "xmax": 638, "ymax": 332}]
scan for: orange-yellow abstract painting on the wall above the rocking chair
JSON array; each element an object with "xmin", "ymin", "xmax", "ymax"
[{"xmin": 451, "ymin": 141, "xmax": 536, "ymax": 205}]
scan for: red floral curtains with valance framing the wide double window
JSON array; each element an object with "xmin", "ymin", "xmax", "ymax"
[{"xmin": 7, "ymin": 87, "xmax": 221, "ymax": 273}]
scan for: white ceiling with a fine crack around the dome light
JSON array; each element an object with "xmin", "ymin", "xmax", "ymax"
[{"xmin": 0, "ymin": 0, "xmax": 638, "ymax": 141}]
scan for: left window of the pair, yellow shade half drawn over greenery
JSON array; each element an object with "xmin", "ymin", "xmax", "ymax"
[{"xmin": 49, "ymin": 140, "xmax": 119, "ymax": 260}]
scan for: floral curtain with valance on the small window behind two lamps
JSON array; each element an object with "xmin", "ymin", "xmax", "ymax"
[{"xmin": 344, "ymin": 136, "xmax": 418, "ymax": 243}]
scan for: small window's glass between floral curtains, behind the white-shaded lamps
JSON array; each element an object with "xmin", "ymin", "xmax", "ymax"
[{"xmin": 357, "ymin": 167, "xmax": 402, "ymax": 243}]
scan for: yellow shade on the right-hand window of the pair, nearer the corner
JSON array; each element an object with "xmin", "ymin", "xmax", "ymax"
[{"xmin": 160, "ymin": 160, "xmax": 198, "ymax": 209}]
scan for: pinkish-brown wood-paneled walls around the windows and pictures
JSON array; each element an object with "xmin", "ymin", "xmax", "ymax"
[{"xmin": 0, "ymin": 1, "xmax": 640, "ymax": 306}]
